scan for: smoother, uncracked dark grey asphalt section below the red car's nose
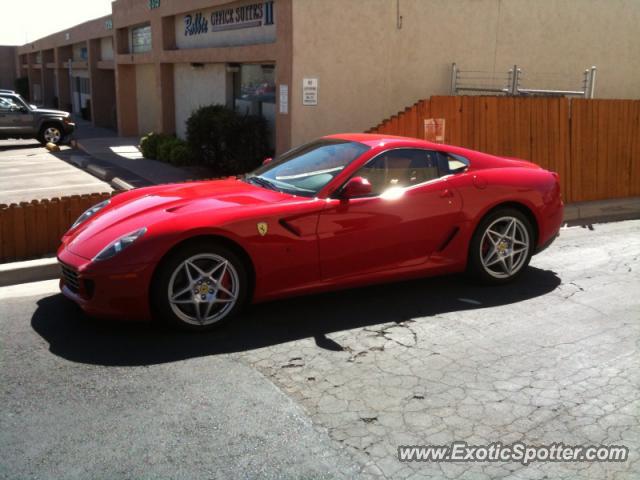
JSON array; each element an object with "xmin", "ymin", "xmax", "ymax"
[{"xmin": 0, "ymin": 281, "xmax": 360, "ymax": 480}]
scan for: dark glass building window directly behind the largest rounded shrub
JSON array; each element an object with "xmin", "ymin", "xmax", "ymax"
[{"xmin": 233, "ymin": 65, "xmax": 276, "ymax": 147}]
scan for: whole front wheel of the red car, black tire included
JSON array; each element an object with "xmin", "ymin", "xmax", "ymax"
[{"xmin": 151, "ymin": 242, "xmax": 248, "ymax": 330}]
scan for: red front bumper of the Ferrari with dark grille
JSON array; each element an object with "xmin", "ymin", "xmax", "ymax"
[{"xmin": 58, "ymin": 248, "xmax": 153, "ymax": 320}]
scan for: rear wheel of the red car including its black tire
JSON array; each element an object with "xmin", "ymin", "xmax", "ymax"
[{"xmin": 467, "ymin": 208, "xmax": 535, "ymax": 285}]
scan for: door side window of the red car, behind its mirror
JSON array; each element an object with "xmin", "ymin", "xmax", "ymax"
[{"xmin": 354, "ymin": 148, "xmax": 441, "ymax": 195}]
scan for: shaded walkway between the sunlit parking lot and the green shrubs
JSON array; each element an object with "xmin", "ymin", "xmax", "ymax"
[{"xmin": 71, "ymin": 120, "xmax": 194, "ymax": 189}]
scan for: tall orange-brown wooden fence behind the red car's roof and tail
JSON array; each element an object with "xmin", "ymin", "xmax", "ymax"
[{"xmin": 369, "ymin": 96, "xmax": 640, "ymax": 202}]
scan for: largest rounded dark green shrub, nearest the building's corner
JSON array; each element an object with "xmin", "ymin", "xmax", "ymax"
[{"xmin": 187, "ymin": 105, "xmax": 271, "ymax": 175}]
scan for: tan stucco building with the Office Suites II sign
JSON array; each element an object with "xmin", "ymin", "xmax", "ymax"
[{"xmin": 13, "ymin": 0, "xmax": 640, "ymax": 152}]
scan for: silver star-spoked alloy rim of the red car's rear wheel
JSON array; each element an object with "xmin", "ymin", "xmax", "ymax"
[{"xmin": 480, "ymin": 217, "xmax": 531, "ymax": 278}]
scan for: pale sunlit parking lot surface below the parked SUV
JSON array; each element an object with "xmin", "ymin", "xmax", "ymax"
[{"xmin": 0, "ymin": 140, "xmax": 112, "ymax": 204}]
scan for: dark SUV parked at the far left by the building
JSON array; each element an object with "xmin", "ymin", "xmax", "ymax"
[{"xmin": 0, "ymin": 90, "xmax": 75, "ymax": 144}]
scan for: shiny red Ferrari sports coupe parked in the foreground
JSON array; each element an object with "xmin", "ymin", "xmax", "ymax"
[{"xmin": 58, "ymin": 134, "xmax": 563, "ymax": 330}]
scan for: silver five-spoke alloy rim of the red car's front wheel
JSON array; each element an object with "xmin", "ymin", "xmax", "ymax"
[{"xmin": 167, "ymin": 253, "xmax": 240, "ymax": 325}]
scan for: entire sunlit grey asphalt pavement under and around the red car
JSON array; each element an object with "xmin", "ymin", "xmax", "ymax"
[{"xmin": 0, "ymin": 221, "xmax": 640, "ymax": 480}]
